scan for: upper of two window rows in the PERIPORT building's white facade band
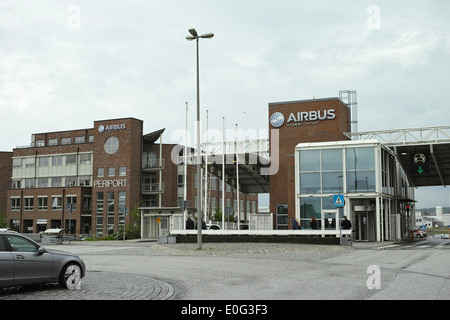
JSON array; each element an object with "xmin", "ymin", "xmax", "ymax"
[{"xmin": 13, "ymin": 153, "xmax": 92, "ymax": 168}]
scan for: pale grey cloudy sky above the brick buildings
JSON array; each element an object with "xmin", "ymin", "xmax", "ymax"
[{"xmin": 0, "ymin": 0, "xmax": 450, "ymax": 207}]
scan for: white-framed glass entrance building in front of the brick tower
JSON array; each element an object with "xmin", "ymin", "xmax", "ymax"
[{"xmin": 295, "ymin": 140, "xmax": 414, "ymax": 241}]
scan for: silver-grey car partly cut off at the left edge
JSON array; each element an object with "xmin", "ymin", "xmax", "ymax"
[{"xmin": 0, "ymin": 231, "xmax": 86, "ymax": 289}]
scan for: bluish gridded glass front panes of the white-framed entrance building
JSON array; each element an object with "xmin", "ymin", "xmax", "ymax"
[{"xmin": 297, "ymin": 146, "xmax": 377, "ymax": 229}]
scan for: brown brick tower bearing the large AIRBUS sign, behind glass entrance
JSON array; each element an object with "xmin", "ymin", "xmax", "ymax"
[{"xmin": 269, "ymin": 98, "xmax": 351, "ymax": 229}]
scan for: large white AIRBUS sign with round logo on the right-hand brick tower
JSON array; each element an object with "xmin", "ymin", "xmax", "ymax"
[{"xmin": 270, "ymin": 109, "xmax": 336, "ymax": 128}]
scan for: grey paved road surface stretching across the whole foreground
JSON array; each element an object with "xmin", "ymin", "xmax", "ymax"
[{"xmin": 0, "ymin": 239, "xmax": 450, "ymax": 301}]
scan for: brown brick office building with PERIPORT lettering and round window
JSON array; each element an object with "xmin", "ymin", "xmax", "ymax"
[{"xmin": 0, "ymin": 118, "xmax": 257, "ymax": 235}]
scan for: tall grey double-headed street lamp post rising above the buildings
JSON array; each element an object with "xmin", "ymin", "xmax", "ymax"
[{"xmin": 186, "ymin": 28, "xmax": 214, "ymax": 250}]
